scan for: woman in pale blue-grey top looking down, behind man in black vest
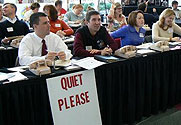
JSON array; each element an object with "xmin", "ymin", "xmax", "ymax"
[{"xmin": 64, "ymin": 4, "xmax": 85, "ymax": 24}]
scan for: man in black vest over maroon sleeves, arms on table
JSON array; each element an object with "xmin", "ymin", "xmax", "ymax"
[{"xmin": 73, "ymin": 10, "xmax": 117, "ymax": 57}]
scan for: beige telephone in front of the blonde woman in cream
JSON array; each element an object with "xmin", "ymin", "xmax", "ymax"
[{"xmin": 150, "ymin": 41, "xmax": 170, "ymax": 52}]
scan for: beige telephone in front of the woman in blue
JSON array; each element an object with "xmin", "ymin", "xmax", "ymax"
[{"xmin": 114, "ymin": 45, "xmax": 136, "ymax": 58}]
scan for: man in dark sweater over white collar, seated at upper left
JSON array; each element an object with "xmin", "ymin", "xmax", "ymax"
[{"xmin": 0, "ymin": 3, "xmax": 30, "ymax": 43}]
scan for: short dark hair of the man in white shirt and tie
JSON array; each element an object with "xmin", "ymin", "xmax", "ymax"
[{"xmin": 30, "ymin": 12, "xmax": 47, "ymax": 27}]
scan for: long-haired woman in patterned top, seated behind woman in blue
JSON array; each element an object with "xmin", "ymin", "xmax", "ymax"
[{"xmin": 107, "ymin": 2, "xmax": 127, "ymax": 31}]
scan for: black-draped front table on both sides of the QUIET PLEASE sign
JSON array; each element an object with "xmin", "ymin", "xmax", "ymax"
[{"xmin": 0, "ymin": 50, "xmax": 181, "ymax": 125}]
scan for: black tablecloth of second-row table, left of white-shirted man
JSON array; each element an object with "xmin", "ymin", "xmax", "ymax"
[{"xmin": 0, "ymin": 48, "xmax": 18, "ymax": 68}]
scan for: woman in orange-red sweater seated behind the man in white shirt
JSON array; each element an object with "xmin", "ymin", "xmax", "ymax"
[{"xmin": 43, "ymin": 5, "xmax": 74, "ymax": 37}]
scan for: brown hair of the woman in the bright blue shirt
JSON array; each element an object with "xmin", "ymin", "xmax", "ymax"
[{"xmin": 128, "ymin": 10, "xmax": 143, "ymax": 26}]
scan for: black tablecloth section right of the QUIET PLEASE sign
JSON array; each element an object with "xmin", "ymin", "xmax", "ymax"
[{"xmin": 95, "ymin": 50, "xmax": 181, "ymax": 125}]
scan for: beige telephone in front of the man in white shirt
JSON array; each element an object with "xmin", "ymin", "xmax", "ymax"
[{"xmin": 29, "ymin": 60, "xmax": 52, "ymax": 75}]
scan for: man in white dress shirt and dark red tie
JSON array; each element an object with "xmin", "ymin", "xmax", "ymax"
[{"xmin": 18, "ymin": 12, "xmax": 72, "ymax": 65}]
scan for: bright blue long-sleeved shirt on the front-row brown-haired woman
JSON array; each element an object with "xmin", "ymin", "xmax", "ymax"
[{"xmin": 111, "ymin": 25, "xmax": 146, "ymax": 47}]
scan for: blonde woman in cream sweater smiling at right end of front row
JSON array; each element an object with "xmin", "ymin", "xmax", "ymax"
[{"xmin": 152, "ymin": 8, "xmax": 181, "ymax": 42}]
